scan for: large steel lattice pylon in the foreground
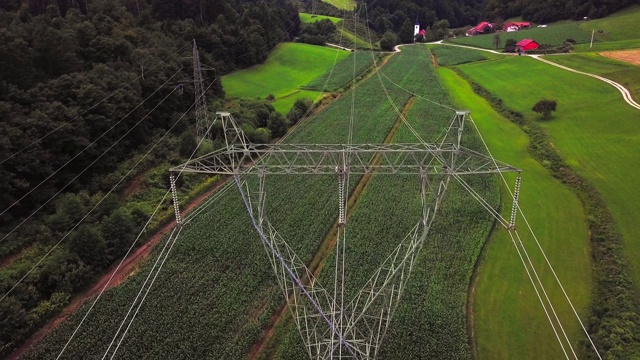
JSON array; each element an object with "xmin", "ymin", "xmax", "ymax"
[{"xmin": 172, "ymin": 111, "xmax": 520, "ymax": 359}]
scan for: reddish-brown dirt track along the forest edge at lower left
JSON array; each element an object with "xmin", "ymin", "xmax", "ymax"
[{"xmin": 7, "ymin": 179, "xmax": 228, "ymax": 360}]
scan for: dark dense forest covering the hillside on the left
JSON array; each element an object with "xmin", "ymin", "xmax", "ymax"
[{"xmin": 0, "ymin": 0, "xmax": 300, "ymax": 356}]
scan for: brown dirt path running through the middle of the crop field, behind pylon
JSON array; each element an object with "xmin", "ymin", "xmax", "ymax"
[{"xmin": 248, "ymin": 97, "xmax": 415, "ymax": 360}]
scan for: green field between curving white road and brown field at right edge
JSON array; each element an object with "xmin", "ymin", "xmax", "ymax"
[{"xmin": 545, "ymin": 52, "xmax": 640, "ymax": 102}]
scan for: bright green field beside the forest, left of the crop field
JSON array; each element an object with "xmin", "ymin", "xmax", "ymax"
[{"xmin": 222, "ymin": 43, "xmax": 349, "ymax": 112}]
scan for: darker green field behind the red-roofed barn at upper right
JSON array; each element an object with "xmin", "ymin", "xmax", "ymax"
[{"xmin": 449, "ymin": 22, "xmax": 591, "ymax": 49}]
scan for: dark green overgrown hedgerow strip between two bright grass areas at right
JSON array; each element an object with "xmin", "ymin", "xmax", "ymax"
[{"xmin": 458, "ymin": 71, "xmax": 640, "ymax": 359}]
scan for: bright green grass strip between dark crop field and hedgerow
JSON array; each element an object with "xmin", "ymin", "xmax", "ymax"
[{"xmin": 439, "ymin": 65, "xmax": 592, "ymax": 359}]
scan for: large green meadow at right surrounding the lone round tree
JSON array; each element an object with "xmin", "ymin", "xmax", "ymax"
[{"xmin": 460, "ymin": 57, "xmax": 640, "ymax": 294}]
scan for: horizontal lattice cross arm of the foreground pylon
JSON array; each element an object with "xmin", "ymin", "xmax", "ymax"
[{"xmin": 171, "ymin": 143, "xmax": 520, "ymax": 175}]
